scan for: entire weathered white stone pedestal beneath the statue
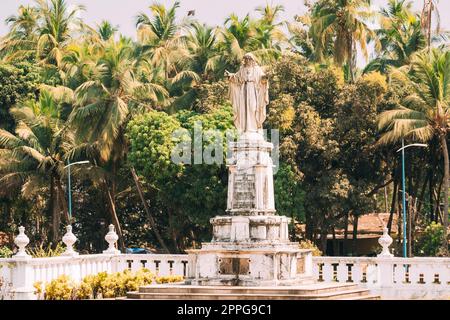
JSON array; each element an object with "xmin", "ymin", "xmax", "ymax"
[{"xmin": 188, "ymin": 133, "xmax": 312, "ymax": 286}]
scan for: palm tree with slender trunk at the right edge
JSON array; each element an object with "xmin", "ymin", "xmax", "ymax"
[{"xmin": 379, "ymin": 49, "xmax": 450, "ymax": 255}]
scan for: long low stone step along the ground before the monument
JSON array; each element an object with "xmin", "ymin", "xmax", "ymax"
[{"xmin": 127, "ymin": 289, "xmax": 369, "ymax": 300}]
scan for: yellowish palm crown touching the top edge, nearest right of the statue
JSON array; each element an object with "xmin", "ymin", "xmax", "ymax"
[{"xmin": 310, "ymin": 0, "xmax": 375, "ymax": 81}]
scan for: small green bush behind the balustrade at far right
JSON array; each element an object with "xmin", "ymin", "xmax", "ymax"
[{"xmin": 414, "ymin": 221, "xmax": 445, "ymax": 257}]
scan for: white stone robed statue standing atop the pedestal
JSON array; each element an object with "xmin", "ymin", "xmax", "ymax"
[{"xmin": 225, "ymin": 53, "xmax": 269, "ymax": 133}]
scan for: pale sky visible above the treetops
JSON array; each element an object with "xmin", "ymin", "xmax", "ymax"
[{"xmin": 0, "ymin": 0, "xmax": 450, "ymax": 63}]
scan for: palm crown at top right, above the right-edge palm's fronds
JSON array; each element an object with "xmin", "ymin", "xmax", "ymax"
[{"xmin": 364, "ymin": 0, "xmax": 425, "ymax": 73}]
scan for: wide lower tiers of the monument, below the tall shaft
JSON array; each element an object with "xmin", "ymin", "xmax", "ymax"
[{"xmin": 187, "ymin": 216, "xmax": 313, "ymax": 286}]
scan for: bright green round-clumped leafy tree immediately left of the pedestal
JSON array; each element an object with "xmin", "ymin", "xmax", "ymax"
[{"xmin": 127, "ymin": 107, "xmax": 234, "ymax": 250}]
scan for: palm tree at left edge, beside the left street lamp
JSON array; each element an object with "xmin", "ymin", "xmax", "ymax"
[{"xmin": 0, "ymin": 90, "xmax": 69, "ymax": 243}]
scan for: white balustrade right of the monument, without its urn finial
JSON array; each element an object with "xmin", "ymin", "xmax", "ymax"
[{"xmin": 313, "ymin": 255, "xmax": 450, "ymax": 299}]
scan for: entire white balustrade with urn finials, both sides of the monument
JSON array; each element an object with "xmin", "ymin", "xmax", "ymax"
[{"xmin": 0, "ymin": 227, "xmax": 450, "ymax": 299}]
